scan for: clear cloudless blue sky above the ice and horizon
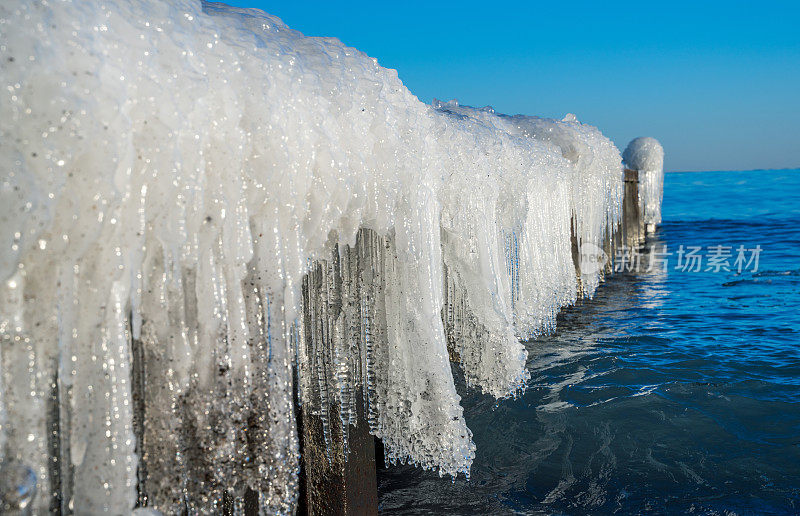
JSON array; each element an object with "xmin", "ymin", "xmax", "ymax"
[{"xmin": 222, "ymin": 0, "xmax": 800, "ymax": 170}]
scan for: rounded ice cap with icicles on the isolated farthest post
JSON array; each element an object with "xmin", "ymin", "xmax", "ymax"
[{"xmin": 622, "ymin": 136, "xmax": 664, "ymax": 224}]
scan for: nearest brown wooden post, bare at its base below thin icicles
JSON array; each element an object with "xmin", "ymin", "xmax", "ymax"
[{"xmin": 298, "ymin": 229, "xmax": 378, "ymax": 516}]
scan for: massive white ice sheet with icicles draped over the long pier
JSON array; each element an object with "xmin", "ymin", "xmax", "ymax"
[{"xmin": 0, "ymin": 0, "xmax": 636, "ymax": 514}]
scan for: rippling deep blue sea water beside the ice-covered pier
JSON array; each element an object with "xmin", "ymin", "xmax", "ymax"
[{"xmin": 379, "ymin": 170, "xmax": 800, "ymax": 514}]
